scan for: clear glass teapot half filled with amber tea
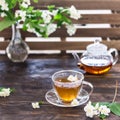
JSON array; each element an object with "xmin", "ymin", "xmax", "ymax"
[{"xmin": 72, "ymin": 40, "xmax": 118, "ymax": 74}]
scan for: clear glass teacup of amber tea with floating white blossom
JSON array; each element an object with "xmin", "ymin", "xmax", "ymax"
[{"xmin": 52, "ymin": 70, "xmax": 93, "ymax": 103}]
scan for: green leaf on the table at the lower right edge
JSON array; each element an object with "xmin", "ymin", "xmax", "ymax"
[{"xmin": 109, "ymin": 102, "xmax": 120, "ymax": 116}]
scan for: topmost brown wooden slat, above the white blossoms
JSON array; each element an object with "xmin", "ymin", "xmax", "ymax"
[{"xmin": 31, "ymin": 0, "xmax": 120, "ymax": 10}]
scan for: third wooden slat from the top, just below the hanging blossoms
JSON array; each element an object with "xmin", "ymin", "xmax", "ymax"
[{"xmin": 0, "ymin": 28, "xmax": 120, "ymax": 39}]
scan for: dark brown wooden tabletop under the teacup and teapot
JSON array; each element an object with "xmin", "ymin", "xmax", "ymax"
[{"xmin": 0, "ymin": 56, "xmax": 120, "ymax": 120}]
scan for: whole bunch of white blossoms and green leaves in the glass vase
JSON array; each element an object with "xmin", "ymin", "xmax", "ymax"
[{"xmin": 0, "ymin": 0, "xmax": 81, "ymax": 37}]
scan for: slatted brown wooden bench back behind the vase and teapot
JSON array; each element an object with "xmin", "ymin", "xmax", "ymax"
[{"xmin": 0, "ymin": 0, "xmax": 120, "ymax": 53}]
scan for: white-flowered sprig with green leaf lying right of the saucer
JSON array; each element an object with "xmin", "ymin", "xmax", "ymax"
[{"xmin": 84, "ymin": 101, "xmax": 120, "ymax": 120}]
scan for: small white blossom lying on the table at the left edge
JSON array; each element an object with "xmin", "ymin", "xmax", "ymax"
[{"xmin": 0, "ymin": 87, "xmax": 15, "ymax": 97}]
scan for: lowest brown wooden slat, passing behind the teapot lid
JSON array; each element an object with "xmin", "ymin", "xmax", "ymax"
[{"xmin": 0, "ymin": 38, "xmax": 120, "ymax": 50}]
